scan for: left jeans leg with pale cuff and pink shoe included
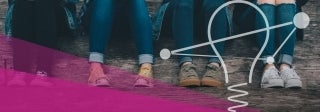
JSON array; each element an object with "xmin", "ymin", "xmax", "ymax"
[{"xmin": 88, "ymin": 0, "xmax": 115, "ymax": 86}]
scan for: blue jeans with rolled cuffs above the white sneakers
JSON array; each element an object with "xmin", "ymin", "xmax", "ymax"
[{"xmin": 256, "ymin": 4, "xmax": 296, "ymax": 65}]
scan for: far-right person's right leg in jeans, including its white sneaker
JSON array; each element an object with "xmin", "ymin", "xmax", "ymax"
[{"xmin": 276, "ymin": 0, "xmax": 302, "ymax": 89}]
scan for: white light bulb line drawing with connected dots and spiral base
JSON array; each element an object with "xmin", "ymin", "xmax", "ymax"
[{"xmin": 160, "ymin": 0, "xmax": 310, "ymax": 112}]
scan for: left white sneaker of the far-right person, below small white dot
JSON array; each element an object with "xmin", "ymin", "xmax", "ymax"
[{"xmin": 261, "ymin": 67, "xmax": 284, "ymax": 88}]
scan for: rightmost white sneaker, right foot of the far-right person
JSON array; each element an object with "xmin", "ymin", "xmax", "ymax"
[{"xmin": 280, "ymin": 69, "xmax": 302, "ymax": 89}]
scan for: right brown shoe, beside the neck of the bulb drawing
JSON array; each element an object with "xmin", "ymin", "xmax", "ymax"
[{"xmin": 201, "ymin": 64, "xmax": 223, "ymax": 87}]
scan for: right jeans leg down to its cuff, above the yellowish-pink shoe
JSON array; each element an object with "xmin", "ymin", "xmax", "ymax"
[{"xmin": 128, "ymin": 0, "xmax": 153, "ymax": 65}]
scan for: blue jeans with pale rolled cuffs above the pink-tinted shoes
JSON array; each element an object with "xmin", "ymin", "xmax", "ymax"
[{"xmin": 89, "ymin": 0, "xmax": 153, "ymax": 64}]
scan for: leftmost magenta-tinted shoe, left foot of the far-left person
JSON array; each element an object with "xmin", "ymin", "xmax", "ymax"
[{"xmin": 7, "ymin": 72, "xmax": 26, "ymax": 86}]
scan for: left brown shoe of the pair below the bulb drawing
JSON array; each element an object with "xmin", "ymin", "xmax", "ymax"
[{"xmin": 179, "ymin": 64, "xmax": 200, "ymax": 87}]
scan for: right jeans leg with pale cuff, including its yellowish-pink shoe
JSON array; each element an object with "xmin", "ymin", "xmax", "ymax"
[{"xmin": 128, "ymin": 0, "xmax": 153, "ymax": 87}]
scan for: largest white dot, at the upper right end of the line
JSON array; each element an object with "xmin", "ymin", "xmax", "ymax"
[{"xmin": 293, "ymin": 12, "xmax": 310, "ymax": 29}]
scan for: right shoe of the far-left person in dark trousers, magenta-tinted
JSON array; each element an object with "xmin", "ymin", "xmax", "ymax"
[{"xmin": 30, "ymin": 71, "xmax": 53, "ymax": 87}]
